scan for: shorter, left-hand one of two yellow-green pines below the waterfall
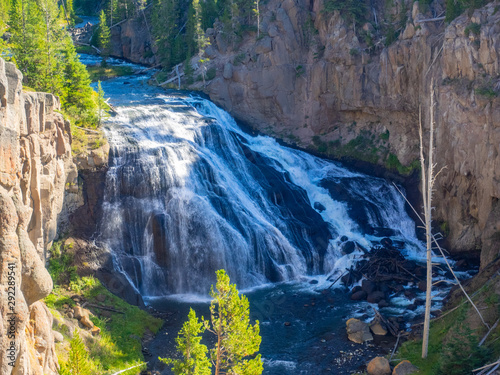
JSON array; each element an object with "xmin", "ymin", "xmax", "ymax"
[{"xmin": 159, "ymin": 309, "xmax": 212, "ymax": 375}]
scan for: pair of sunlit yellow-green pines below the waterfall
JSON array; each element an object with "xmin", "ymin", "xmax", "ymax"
[{"xmin": 160, "ymin": 270, "xmax": 263, "ymax": 375}]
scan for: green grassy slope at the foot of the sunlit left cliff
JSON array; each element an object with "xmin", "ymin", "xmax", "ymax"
[{"xmin": 44, "ymin": 242, "xmax": 163, "ymax": 375}]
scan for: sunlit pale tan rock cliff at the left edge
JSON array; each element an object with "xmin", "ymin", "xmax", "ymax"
[{"xmin": 0, "ymin": 59, "xmax": 77, "ymax": 375}]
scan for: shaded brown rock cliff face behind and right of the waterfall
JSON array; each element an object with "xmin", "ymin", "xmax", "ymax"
[{"xmin": 192, "ymin": 0, "xmax": 500, "ymax": 265}]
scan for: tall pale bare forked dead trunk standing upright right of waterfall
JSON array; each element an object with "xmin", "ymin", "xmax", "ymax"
[{"xmin": 419, "ymin": 80, "xmax": 435, "ymax": 358}]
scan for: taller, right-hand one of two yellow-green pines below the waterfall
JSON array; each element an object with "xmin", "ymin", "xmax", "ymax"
[{"xmin": 205, "ymin": 270, "xmax": 263, "ymax": 375}]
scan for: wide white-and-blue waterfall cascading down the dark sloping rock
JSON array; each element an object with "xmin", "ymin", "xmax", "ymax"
[{"xmin": 99, "ymin": 72, "xmax": 420, "ymax": 297}]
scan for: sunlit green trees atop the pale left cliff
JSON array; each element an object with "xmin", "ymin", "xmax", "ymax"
[{"xmin": 0, "ymin": 0, "xmax": 99, "ymax": 126}]
